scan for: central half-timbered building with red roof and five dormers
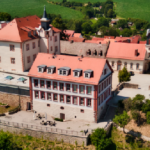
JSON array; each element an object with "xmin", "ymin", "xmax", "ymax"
[{"xmin": 28, "ymin": 53, "xmax": 113, "ymax": 122}]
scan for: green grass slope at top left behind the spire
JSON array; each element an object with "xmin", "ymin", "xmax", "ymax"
[{"xmin": 0, "ymin": 0, "xmax": 83, "ymax": 19}]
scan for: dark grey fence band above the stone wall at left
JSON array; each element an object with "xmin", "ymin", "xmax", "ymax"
[{"xmin": 0, "ymin": 83, "xmax": 30, "ymax": 96}]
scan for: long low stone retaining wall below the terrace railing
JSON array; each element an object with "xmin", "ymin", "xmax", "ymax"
[{"xmin": 0, "ymin": 124, "xmax": 89, "ymax": 145}]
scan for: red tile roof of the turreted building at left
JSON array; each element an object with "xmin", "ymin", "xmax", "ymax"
[{"xmin": 0, "ymin": 15, "xmax": 40, "ymax": 42}]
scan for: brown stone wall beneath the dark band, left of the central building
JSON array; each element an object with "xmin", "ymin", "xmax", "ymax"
[{"xmin": 0, "ymin": 92, "xmax": 30, "ymax": 110}]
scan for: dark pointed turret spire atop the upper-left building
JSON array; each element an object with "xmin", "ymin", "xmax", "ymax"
[{"xmin": 41, "ymin": 6, "xmax": 50, "ymax": 30}]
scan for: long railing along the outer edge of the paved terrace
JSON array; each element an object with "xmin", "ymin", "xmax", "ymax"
[{"xmin": 0, "ymin": 120, "xmax": 87, "ymax": 136}]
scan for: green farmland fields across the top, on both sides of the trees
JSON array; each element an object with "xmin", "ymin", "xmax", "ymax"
[{"xmin": 0, "ymin": 0, "xmax": 150, "ymax": 21}]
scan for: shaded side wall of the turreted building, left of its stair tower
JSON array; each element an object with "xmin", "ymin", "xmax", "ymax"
[{"xmin": 22, "ymin": 39, "xmax": 40, "ymax": 71}]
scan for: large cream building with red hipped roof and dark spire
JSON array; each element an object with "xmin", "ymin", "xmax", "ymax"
[{"xmin": 0, "ymin": 8, "xmax": 61, "ymax": 72}]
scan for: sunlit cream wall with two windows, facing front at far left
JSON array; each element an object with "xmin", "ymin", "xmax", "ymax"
[{"xmin": 0, "ymin": 41, "xmax": 23, "ymax": 72}]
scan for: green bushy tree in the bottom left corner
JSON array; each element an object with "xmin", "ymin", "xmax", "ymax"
[{"xmin": 0, "ymin": 131, "xmax": 15, "ymax": 150}]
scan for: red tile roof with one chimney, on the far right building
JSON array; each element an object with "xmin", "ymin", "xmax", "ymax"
[{"xmin": 106, "ymin": 42, "xmax": 146, "ymax": 60}]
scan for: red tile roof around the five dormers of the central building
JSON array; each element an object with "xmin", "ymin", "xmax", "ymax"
[{"xmin": 28, "ymin": 53, "xmax": 108, "ymax": 85}]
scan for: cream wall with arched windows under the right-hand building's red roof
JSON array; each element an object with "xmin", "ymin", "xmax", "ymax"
[{"xmin": 107, "ymin": 58, "xmax": 144, "ymax": 73}]
